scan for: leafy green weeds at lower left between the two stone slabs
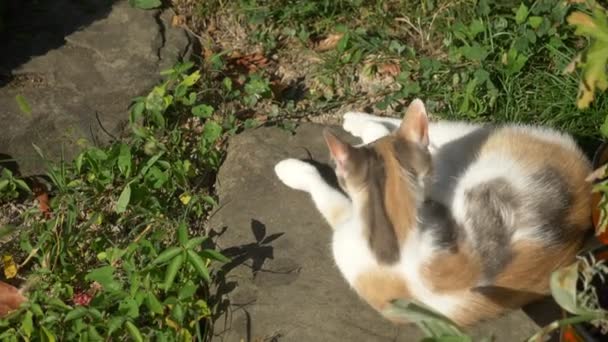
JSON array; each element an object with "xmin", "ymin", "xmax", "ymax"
[{"xmin": 0, "ymin": 63, "xmax": 239, "ymax": 341}]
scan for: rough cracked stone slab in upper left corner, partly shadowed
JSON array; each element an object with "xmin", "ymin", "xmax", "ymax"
[{"xmin": 0, "ymin": 0, "xmax": 191, "ymax": 174}]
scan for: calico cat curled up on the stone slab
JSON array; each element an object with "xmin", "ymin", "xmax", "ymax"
[{"xmin": 275, "ymin": 99, "xmax": 591, "ymax": 326}]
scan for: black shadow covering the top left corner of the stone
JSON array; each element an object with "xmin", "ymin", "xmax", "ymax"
[{"xmin": 0, "ymin": 0, "xmax": 114, "ymax": 87}]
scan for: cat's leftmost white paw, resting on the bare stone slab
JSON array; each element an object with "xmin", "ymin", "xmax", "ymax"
[{"xmin": 274, "ymin": 158, "xmax": 323, "ymax": 192}]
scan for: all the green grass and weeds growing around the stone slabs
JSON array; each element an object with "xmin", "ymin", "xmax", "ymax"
[{"xmin": 0, "ymin": 0, "xmax": 608, "ymax": 341}]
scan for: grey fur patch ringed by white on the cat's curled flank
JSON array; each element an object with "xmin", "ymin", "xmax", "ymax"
[{"xmin": 465, "ymin": 178, "xmax": 521, "ymax": 281}]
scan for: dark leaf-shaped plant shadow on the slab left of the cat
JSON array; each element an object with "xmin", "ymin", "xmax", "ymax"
[{"xmin": 208, "ymin": 219, "xmax": 284, "ymax": 341}]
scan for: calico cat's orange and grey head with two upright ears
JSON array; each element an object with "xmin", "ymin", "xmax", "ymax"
[{"xmin": 323, "ymin": 99, "xmax": 431, "ymax": 202}]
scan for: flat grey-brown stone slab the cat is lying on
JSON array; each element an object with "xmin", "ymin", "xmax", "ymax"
[{"xmin": 210, "ymin": 124, "xmax": 546, "ymax": 342}]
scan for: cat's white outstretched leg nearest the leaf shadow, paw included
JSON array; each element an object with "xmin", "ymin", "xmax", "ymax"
[{"xmin": 274, "ymin": 159, "xmax": 353, "ymax": 228}]
